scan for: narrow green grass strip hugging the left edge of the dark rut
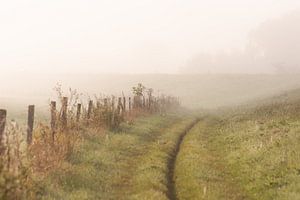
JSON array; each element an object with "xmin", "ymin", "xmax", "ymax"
[{"xmin": 129, "ymin": 118, "xmax": 193, "ymax": 200}]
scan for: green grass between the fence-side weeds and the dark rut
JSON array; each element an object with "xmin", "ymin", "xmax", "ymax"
[{"xmin": 36, "ymin": 115, "xmax": 197, "ymax": 200}]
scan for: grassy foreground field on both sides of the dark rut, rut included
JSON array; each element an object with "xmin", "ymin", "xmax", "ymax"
[{"xmin": 25, "ymin": 90, "xmax": 300, "ymax": 200}]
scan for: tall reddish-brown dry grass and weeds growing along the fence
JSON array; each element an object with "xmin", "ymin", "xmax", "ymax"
[{"xmin": 0, "ymin": 85, "xmax": 179, "ymax": 199}]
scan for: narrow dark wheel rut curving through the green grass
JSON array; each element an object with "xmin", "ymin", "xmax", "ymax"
[{"xmin": 167, "ymin": 118, "xmax": 200, "ymax": 200}]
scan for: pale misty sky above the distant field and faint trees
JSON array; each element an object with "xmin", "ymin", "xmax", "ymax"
[{"xmin": 0, "ymin": 0, "xmax": 300, "ymax": 73}]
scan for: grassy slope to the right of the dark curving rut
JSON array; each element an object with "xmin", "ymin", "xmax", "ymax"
[{"xmin": 175, "ymin": 93, "xmax": 300, "ymax": 200}]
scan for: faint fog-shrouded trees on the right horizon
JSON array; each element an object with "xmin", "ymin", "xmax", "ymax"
[{"xmin": 182, "ymin": 9, "xmax": 300, "ymax": 73}]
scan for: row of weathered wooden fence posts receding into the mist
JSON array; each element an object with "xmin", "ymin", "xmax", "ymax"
[{"xmin": 0, "ymin": 93, "xmax": 179, "ymax": 151}]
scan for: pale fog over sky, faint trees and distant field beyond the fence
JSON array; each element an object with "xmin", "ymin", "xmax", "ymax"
[{"xmin": 0, "ymin": 0, "xmax": 300, "ymax": 112}]
